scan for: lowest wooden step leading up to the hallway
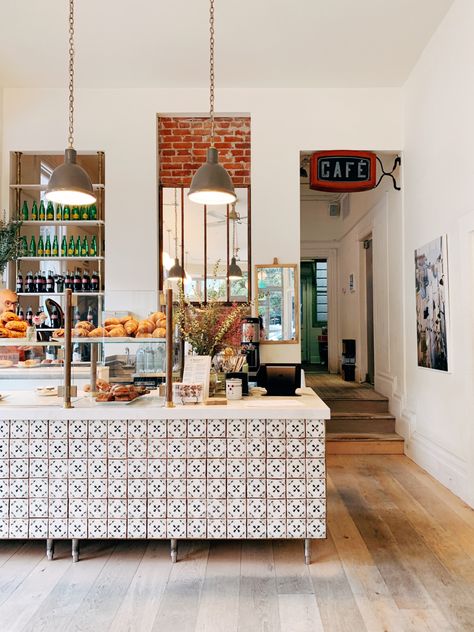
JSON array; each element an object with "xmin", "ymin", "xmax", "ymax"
[{"xmin": 326, "ymin": 432, "xmax": 404, "ymax": 454}]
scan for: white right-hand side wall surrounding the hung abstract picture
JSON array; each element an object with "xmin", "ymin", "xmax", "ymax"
[{"xmin": 401, "ymin": 0, "xmax": 474, "ymax": 505}]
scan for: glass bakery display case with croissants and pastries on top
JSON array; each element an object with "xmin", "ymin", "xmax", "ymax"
[{"xmin": 0, "ymin": 304, "xmax": 180, "ymax": 406}]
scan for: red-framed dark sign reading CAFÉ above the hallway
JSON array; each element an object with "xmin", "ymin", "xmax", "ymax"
[{"xmin": 309, "ymin": 150, "xmax": 377, "ymax": 193}]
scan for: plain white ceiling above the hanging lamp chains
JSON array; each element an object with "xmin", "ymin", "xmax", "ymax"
[{"xmin": 0, "ymin": 0, "xmax": 453, "ymax": 88}]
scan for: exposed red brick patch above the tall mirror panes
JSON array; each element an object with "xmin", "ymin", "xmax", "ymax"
[{"xmin": 158, "ymin": 116, "xmax": 250, "ymax": 187}]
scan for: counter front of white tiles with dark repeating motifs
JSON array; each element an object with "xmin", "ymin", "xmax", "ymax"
[{"xmin": 0, "ymin": 390, "xmax": 329, "ymax": 564}]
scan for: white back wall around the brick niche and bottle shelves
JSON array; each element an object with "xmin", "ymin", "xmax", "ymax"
[{"xmin": 2, "ymin": 88, "xmax": 401, "ymax": 361}]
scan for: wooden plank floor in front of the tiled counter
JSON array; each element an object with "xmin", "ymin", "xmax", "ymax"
[{"xmin": 0, "ymin": 455, "xmax": 474, "ymax": 632}]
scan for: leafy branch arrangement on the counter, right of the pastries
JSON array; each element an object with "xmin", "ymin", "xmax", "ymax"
[{"xmin": 176, "ymin": 274, "xmax": 249, "ymax": 356}]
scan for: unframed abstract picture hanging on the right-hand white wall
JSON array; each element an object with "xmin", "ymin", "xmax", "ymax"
[{"xmin": 415, "ymin": 235, "xmax": 448, "ymax": 371}]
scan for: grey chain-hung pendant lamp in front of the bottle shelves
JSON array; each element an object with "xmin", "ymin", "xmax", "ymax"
[{"xmin": 45, "ymin": 0, "xmax": 96, "ymax": 206}]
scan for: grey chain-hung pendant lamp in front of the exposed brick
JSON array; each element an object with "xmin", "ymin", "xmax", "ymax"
[{"xmin": 188, "ymin": 0, "xmax": 237, "ymax": 204}]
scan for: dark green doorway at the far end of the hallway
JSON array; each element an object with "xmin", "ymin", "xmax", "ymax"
[{"xmin": 301, "ymin": 259, "xmax": 328, "ymax": 373}]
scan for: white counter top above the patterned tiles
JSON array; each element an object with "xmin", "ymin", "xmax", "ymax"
[{"xmin": 0, "ymin": 389, "xmax": 330, "ymax": 419}]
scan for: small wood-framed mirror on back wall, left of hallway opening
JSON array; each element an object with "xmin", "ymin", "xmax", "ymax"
[{"xmin": 255, "ymin": 264, "xmax": 299, "ymax": 344}]
